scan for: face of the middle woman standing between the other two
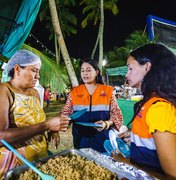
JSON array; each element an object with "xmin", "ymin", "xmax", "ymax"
[{"xmin": 81, "ymin": 62, "xmax": 98, "ymax": 84}]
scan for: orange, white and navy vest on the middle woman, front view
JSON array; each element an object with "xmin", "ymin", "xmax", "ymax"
[{"xmin": 71, "ymin": 84, "xmax": 113, "ymax": 152}]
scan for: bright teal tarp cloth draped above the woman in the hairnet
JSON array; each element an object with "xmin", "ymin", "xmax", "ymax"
[{"xmin": 0, "ymin": 0, "xmax": 42, "ymax": 58}]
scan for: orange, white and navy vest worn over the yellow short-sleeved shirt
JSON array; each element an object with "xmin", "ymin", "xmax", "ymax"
[{"xmin": 131, "ymin": 97, "xmax": 169, "ymax": 171}]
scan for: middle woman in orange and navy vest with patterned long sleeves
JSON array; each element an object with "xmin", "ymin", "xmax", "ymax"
[{"xmin": 61, "ymin": 59, "xmax": 122, "ymax": 152}]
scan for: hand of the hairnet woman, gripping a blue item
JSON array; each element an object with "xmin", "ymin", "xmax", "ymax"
[{"xmin": 46, "ymin": 116, "xmax": 70, "ymax": 132}]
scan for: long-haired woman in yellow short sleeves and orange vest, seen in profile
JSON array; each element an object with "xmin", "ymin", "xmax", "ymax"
[{"xmin": 120, "ymin": 43, "xmax": 176, "ymax": 179}]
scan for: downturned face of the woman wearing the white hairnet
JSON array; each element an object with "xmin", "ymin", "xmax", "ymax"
[{"xmin": 18, "ymin": 64, "xmax": 41, "ymax": 88}]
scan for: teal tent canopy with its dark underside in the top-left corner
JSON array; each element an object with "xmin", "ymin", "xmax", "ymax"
[{"xmin": 0, "ymin": 0, "xmax": 42, "ymax": 58}]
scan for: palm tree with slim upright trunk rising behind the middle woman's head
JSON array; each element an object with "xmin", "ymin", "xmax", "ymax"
[{"xmin": 80, "ymin": 0, "xmax": 118, "ymax": 69}]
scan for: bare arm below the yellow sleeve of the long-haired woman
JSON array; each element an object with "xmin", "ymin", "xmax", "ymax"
[{"xmin": 153, "ymin": 131, "xmax": 176, "ymax": 179}]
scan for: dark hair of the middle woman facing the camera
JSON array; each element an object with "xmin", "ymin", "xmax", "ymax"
[{"xmin": 80, "ymin": 58, "xmax": 104, "ymax": 84}]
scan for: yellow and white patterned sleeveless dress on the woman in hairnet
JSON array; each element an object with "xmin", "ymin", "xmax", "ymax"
[{"xmin": 0, "ymin": 83, "xmax": 47, "ymax": 179}]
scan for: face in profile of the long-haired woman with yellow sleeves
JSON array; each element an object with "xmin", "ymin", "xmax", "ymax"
[{"xmin": 126, "ymin": 56, "xmax": 150, "ymax": 89}]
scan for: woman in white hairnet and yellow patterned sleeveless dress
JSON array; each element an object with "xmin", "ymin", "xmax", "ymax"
[{"xmin": 0, "ymin": 50, "xmax": 70, "ymax": 179}]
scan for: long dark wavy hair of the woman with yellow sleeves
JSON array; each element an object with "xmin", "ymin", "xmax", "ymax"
[{"xmin": 130, "ymin": 43, "xmax": 176, "ymax": 126}]
